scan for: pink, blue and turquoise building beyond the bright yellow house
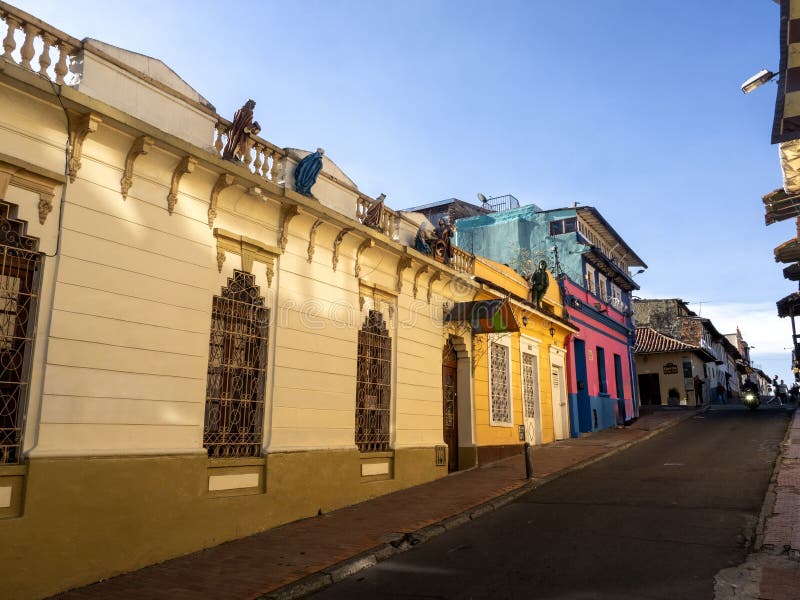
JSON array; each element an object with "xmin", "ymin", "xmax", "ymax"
[{"xmin": 456, "ymin": 205, "xmax": 646, "ymax": 436}]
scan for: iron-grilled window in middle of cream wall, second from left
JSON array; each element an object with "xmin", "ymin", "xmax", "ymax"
[{"xmin": 203, "ymin": 271, "xmax": 269, "ymax": 458}]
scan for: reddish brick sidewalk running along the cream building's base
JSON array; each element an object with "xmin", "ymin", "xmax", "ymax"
[{"xmin": 51, "ymin": 410, "xmax": 695, "ymax": 600}]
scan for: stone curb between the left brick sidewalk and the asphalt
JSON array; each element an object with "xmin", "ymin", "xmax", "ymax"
[{"xmin": 264, "ymin": 405, "xmax": 709, "ymax": 600}]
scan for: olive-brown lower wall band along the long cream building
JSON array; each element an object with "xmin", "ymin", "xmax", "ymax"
[{"xmin": 0, "ymin": 447, "xmax": 447, "ymax": 599}]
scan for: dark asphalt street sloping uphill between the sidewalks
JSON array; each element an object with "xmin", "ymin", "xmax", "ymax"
[{"xmin": 314, "ymin": 407, "xmax": 790, "ymax": 600}]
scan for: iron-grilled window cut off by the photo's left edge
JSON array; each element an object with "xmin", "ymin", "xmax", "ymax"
[{"xmin": 0, "ymin": 202, "xmax": 42, "ymax": 465}]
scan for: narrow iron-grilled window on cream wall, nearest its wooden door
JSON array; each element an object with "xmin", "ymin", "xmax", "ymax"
[{"xmin": 356, "ymin": 310, "xmax": 392, "ymax": 452}]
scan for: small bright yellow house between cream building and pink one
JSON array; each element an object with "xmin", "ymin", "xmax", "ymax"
[{"xmin": 456, "ymin": 257, "xmax": 578, "ymax": 463}]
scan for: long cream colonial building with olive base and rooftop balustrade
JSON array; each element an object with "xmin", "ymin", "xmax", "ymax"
[{"xmin": 0, "ymin": 3, "xmax": 488, "ymax": 598}]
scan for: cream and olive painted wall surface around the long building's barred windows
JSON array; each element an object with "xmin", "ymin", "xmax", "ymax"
[{"xmin": 0, "ymin": 57, "xmax": 488, "ymax": 597}]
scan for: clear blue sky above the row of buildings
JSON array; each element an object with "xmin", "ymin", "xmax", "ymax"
[{"xmin": 18, "ymin": 0, "xmax": 795, "ymax": 380}]
